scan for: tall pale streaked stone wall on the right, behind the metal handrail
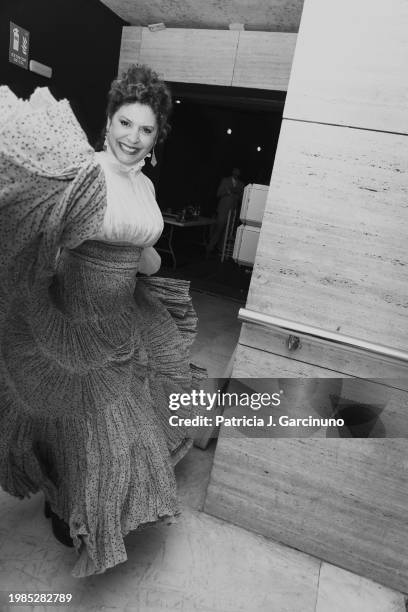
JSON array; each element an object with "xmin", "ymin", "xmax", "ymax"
[{"xmin": 205, "ymin": 0, "xmax": 408, "ymax": 592}]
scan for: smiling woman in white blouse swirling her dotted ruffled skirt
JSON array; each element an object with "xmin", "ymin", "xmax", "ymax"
[{"xmin": 0, "ymin": 66, "xmax": 203, "ymax": 577}]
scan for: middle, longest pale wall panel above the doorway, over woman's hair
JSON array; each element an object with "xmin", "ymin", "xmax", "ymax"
[{"xmin": 140, "ymin": 28, "xmax": 239, "ymax": 85}]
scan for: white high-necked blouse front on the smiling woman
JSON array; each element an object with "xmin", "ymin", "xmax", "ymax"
[{"xmin": 94, "ymin": 147, "xmax": 163, "ymax": 274}]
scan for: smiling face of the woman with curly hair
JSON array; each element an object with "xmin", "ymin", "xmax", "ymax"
[{"xmin": 106, "ymin": 102, "xmax": 158, "ymax": 166}]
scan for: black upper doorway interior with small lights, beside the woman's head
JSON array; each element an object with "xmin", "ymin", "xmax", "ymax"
[{"xmin": 146, "ymin": 83, "xmax": 284, "ymax": 214}]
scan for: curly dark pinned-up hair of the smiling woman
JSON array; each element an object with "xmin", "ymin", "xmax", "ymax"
[{"xmin": 106, "ymin": 64, "xmax": 172, "ymax": 143}]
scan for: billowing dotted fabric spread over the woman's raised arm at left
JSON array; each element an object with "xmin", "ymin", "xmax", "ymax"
[{"xmin": 0, "ymin": 87, "xmax": 106, "ymax": 303}]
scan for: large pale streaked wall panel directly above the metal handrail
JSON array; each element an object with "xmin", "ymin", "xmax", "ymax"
[{"xmin": 247, "ymin": 121, "xmax": 408, "ymax": 350}]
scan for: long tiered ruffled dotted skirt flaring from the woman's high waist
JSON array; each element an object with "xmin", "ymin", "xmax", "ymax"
[{"xmin": 2, "ymin": 241, "xmax": 203, "ymax": 576}]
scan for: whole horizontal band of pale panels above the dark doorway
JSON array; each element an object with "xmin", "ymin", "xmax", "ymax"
[{"xmin": 119, "ymin": 26, "xmax": 296, "ymax": 91}]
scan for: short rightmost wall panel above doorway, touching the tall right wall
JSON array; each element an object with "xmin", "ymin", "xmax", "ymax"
[{"xmin": 232, "ymin": 32, "xmax": 297, "ymax": 91}]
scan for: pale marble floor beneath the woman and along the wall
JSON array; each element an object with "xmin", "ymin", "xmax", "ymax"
[{"xmin": 0, "ymin": 294, "xmax": 406, "ymax": 612}]
